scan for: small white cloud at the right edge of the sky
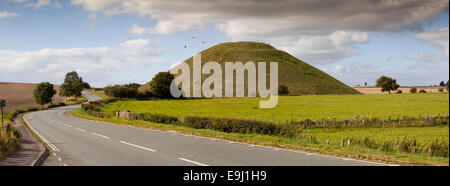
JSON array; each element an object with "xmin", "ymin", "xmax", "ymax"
[{"xmin": 407, "ymin": 27, "xmax": 449, "ymax": 63}]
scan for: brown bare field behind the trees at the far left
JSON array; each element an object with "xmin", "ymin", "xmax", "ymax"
[{"xmin": 0, "ymin": 82, "xmax": 64, "ymax": 111}]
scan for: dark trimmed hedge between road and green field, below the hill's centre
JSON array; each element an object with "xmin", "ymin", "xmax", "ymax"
[{"xmin": 184, "ymin": 117, "xmax": 297, "ymax": 137}]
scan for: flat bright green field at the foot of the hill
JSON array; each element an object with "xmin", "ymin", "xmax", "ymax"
[{"xmin": 103, "ymin": 93, "xmax": 449, "ymax": 122}]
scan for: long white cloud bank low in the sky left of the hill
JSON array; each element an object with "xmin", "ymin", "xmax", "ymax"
[{"xmin": 0, "ymin": 39, "xmax": 161, "ymax": 86}]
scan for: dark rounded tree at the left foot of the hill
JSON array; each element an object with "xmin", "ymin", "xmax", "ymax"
[{"xmin": 150, "ymin": 72, "xmax": 175, "ymax": 98}]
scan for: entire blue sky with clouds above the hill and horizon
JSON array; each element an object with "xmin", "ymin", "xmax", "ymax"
[{"xmin": 0, "ymin": 0, "xmax": 449, "ymax": 87}]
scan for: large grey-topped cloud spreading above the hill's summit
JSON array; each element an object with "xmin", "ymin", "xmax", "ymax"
[{"xmin": 71, "ymin": 0, "xmax": 449, "ymax": 64}]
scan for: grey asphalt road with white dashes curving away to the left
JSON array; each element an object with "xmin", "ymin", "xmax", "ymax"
[{"xmin": 24, "ymin": 92, "xmax": 380, "ymax": 166}]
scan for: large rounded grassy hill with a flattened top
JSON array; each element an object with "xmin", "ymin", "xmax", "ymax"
[{"xmin": 139, "ymin": 42, "xmax": 359, "ymax": 96}]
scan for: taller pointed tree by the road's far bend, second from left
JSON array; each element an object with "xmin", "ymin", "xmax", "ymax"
[{"xmin": 59, "ymin": 71, "xmax": 84, "ymax": 97}]
